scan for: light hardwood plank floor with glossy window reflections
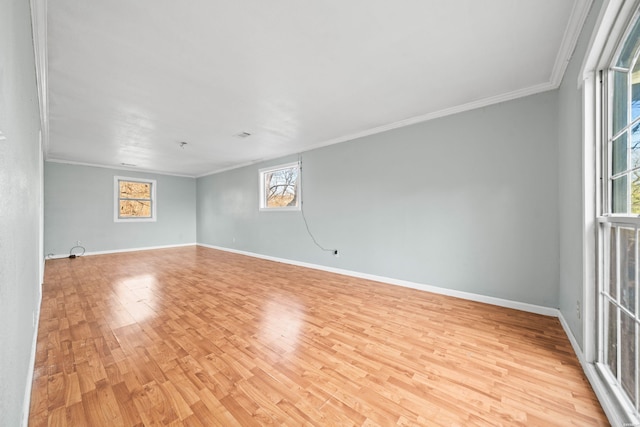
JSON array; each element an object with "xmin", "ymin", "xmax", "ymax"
[{"xmin": 30, "ymin": 247, "xmax": 608, "ymax": 426}]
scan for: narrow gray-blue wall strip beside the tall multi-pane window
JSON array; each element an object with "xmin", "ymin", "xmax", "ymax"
[{"xmin": 558, "ymin": 1, "xmax": 602, "ymax": 347}]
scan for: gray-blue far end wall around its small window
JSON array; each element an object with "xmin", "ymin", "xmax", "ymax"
[{"xmin": 44, "ymin": 162, "xmax": 196, "ymax": 255}]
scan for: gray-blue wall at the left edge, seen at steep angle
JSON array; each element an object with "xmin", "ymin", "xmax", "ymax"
[{"xmin": 0, "ymin": 0, "xmax": 42, "ymax": 426}]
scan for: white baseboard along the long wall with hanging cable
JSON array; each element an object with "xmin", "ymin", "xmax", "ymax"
[{"xmin": 197, "ymin": 243, "xmax": 558, "ymax": 317}]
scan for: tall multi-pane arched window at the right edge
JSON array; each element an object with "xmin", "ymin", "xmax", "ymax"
[{"xmin": 598, "ymin": 10, "xmax": 640, "ymax": 422}]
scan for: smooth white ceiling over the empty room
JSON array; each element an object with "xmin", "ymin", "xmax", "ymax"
[{"xmin": 41, "ymin": 0, "xmax": 591, "ymax": 176}]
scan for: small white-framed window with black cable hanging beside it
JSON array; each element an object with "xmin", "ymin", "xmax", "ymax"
[{"xmin": 259, "ymin": 162, "xmax": 300, "ymax": 211}]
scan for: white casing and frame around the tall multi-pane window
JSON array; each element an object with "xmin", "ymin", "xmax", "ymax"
[{"xmin": 574, "ymin": 0, "xmax": 640, "ymax": 425}]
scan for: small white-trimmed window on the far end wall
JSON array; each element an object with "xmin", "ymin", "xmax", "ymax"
[{"xmin": 114, "ymin": 176, "xmax": 156, "ymax": 222}]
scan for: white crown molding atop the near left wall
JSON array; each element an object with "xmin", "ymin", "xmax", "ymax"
[{"xmin": 30, "ymin": 0, "xmax": 49, "ymax": 155}]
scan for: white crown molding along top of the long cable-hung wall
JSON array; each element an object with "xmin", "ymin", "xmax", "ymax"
[{"xmin": 196, "ymin": 82, "xmax": 558, "ymax": 178}]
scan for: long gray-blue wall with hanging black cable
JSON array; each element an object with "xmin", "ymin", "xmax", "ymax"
[{"xmin": 197, "ymin": 91, "xmax": 559, "ymax": 307}]
